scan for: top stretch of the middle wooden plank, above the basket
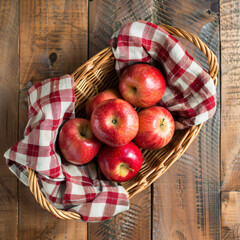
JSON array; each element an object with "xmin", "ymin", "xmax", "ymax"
[{"xmin": 89, "ymin": 0, "xmax": 152, "ymax": 56}]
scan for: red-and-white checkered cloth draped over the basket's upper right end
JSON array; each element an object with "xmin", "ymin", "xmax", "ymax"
[{"xmin": 111, "ymin": 21, "xmax": 216, "ymax": 129}]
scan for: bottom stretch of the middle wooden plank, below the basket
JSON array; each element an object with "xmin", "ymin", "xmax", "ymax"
[{"xmin": 88, "ymin": 188, "xmax": 151, "ymax": 240}]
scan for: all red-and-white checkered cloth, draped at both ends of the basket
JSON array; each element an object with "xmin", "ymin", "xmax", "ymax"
[{"xmin": 4, "ymin": 21, "xmax": 216, "ymax": 222}]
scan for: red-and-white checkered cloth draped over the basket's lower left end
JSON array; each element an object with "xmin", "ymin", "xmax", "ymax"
[{"xmin": 4, "ymin": 75, "xmax": 129, "ymax": 222}]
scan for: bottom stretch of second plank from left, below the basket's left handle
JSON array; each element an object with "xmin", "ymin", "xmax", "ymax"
[{"xmin": 19, "ymin": 186, "xmax": 87, "ymax": 240}]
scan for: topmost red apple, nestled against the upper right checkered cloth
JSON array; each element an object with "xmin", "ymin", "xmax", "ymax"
[{"xmin": 119, "ymin": 63, "xmax": 166, "ymax": 108}]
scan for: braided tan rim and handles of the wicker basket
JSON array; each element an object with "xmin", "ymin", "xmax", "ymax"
[{"xmin": 27, "ymin": 25, "xmax": 219, "ymax": 220}]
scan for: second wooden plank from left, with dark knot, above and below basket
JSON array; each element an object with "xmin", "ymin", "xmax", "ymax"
[{"xmin": 19, "ymin": 0, "xmax": 88, "ymax": 240}]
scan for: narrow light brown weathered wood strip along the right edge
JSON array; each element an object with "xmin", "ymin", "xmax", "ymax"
[{"xmin": 220, "ymin": 0, "xmax": 240, "ymax": 240}]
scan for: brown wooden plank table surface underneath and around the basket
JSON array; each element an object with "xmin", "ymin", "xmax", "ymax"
[{"xmin": 0, "ymin": 0, "xmax": 240, "ymax": 240}]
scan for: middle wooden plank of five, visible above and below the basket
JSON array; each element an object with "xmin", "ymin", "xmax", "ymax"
[{"xmin": 88, "ymin": 0, "xmax": 152, "ymax": 240}]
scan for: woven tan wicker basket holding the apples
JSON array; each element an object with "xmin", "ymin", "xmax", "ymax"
[{"xmin": 28, "ymin": 25, "xmax": 218, "ymax": 220}]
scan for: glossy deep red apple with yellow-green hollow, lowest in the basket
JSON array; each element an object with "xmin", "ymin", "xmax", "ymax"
[{"xmin": 98, "ymin": 142, "xmax": 143, "ymax": 182}]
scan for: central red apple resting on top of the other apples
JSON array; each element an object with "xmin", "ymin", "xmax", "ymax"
[{"xmin": 91, "ymin": 99, "xmax": 138, "ymax": 147}]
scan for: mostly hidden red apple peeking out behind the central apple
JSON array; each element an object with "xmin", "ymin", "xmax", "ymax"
[{"xmin": 86, "ymin": 89, "xmax": 121, "ymax": 118}]
